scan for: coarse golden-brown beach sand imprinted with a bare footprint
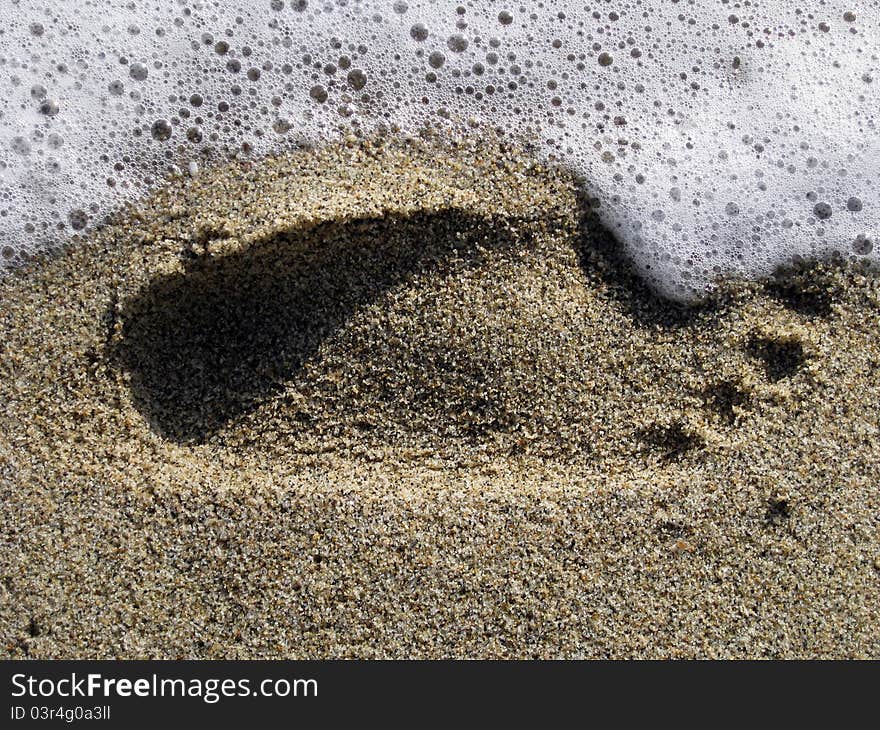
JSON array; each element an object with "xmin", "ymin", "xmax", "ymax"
[{"xmin": 0, "ymin": 135, "xmax": 880, "ymax": 658}]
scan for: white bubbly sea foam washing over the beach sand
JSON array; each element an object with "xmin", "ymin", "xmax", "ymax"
[{"xmin": 0, "ymin": 0, "xmax": 880, "ymax": 299}]
